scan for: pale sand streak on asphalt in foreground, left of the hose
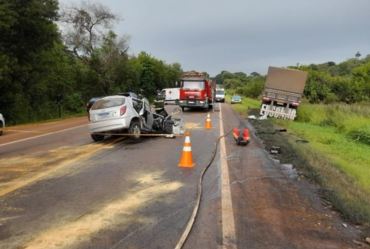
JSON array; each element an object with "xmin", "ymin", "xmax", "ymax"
[{"xmin": 22, "ymin": 174, "xmax": 182, "ymax": 249}]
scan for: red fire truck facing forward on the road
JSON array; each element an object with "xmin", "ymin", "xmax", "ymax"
[{"xmin": 178, "ymin": 71, "xmax": 216, "ymax": 111}]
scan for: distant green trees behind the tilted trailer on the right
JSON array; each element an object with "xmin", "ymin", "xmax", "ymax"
[{"xmin": 215, "ymin": 53, "xmax": 370, "ymax": 104}]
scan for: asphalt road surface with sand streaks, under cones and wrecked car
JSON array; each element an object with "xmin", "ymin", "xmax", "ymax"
[{"xmin": 0, "ymin": 105, "xmax": 364, "ymax": 249}]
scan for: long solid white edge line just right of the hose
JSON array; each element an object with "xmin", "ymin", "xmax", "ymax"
[{"xmin": 220, "ymin": 106, "xmax": 236, "ymax": 249}]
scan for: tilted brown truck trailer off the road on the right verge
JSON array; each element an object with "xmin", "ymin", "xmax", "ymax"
[{"xmin": 260, "ymin": 67, "xmax": 307, "ymax": 120}]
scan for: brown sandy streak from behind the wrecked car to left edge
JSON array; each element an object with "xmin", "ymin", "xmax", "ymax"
[{"xmin": 0, "ymin": 138, "xmax": 122, "ymax": 196}]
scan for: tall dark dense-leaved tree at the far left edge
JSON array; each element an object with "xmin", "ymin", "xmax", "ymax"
[{"xmin": 0, "ymin": 0, "xmax": 60, "ymax": 123}]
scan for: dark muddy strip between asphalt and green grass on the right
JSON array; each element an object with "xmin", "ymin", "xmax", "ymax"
[{"xmin": 249, "ymin": 109, "xmax": 370, "ymax": 245}]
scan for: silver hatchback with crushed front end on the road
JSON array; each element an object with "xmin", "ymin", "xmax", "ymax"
[{"xmin": 89, "ymin": 95, "xmax": 173, "ymax": 141}]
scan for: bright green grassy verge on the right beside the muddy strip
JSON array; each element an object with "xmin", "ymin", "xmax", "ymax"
[{"xmin": 233, "ymin": 99, "xmax": 370, "ymax": 226}]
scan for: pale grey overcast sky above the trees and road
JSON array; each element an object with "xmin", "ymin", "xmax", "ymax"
[{"xmin": 60, "ymin": 0, "xmax": 370, "ymax": 76}]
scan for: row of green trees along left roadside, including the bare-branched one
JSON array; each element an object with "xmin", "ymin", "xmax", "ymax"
[{"xmin": 0, "ymin": 0, "xmax": 182, "ymax": 124}]
